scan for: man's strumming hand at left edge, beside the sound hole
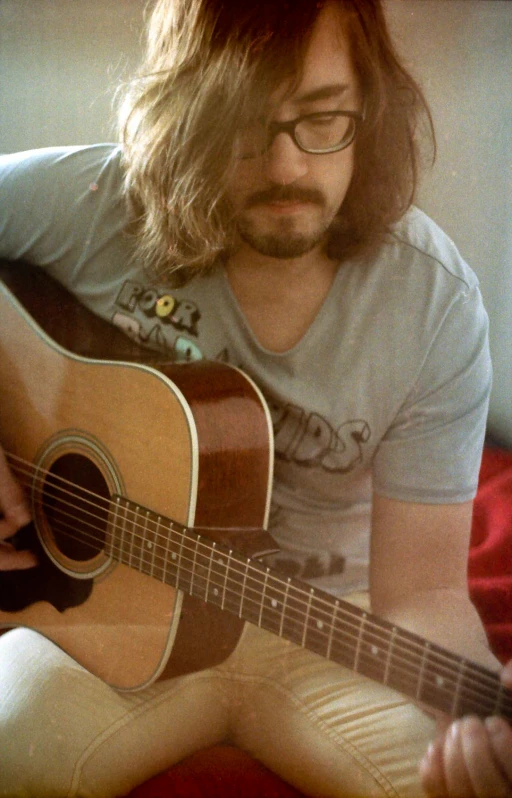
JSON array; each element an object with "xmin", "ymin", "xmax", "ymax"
[{"xmin": 0, "ymin": 449, "xmax": 37, "ymax": 571}]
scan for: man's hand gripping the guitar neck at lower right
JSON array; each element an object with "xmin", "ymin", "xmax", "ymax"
[{"xmin": 420, "ymin": 660, "xmax": 512, "ymax": 798}]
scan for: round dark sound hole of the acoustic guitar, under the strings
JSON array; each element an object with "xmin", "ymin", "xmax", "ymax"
[{"xmin": 42, "ymin": 454, "xmax": 110, "ymax": 561}]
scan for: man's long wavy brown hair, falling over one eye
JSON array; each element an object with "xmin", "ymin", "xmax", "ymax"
[{"xmin": 120, "ymin": 0, "xmax": 435, "ymax": 283}]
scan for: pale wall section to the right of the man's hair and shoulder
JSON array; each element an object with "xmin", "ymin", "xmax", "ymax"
[{"xmin": 388, "ymin": 0, "xmax": 512, "ymax": 446}]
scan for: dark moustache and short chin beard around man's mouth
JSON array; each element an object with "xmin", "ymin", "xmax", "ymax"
[{"xmin": 236, "ymin": 186, "xmax": 335, "ymax": 260}]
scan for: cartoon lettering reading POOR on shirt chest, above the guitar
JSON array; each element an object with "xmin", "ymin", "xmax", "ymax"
[{"xmin": 112, "ymin": 280, "xmax": 203, "ymax": 362}]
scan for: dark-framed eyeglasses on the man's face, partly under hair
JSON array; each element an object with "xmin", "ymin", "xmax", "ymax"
[{"xmin": 237, "ymin": 111, "xmax": 364, "ymax": 159}]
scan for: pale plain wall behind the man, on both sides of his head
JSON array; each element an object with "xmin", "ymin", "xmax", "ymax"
[{"xmin": 0, "ymin": 0, "xmax": 512, "ymax": 446}]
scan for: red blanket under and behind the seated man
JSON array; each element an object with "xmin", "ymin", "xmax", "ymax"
[{"xmin": 127, "ymin": 447, "xmax": 512, "ymax": 798}]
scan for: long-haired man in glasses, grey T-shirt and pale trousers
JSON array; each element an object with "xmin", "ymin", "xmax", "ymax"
[{"xmin": 0, "ymin": 0, "xmax": 512, "ymax": 798}]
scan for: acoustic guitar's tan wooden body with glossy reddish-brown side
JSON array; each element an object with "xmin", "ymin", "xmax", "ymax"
[{"xmin": 0, "ymin": 266, "xmax": 272, "ymax": 690}]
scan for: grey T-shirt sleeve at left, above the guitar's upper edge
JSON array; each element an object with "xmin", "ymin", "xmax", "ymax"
[{"xmin": 0, "ymin": 144, "xmax": 126, "ymax": 284}]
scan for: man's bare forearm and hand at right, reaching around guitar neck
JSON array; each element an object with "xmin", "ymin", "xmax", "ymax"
[{"xmin": 371, "ymin": 496, "xmax": 512, "ymax": 798}]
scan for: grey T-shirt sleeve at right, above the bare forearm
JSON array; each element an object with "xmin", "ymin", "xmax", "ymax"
[{"xmin": 373, "ymin": 285, "xmax": 492, "ymax": 503}]
